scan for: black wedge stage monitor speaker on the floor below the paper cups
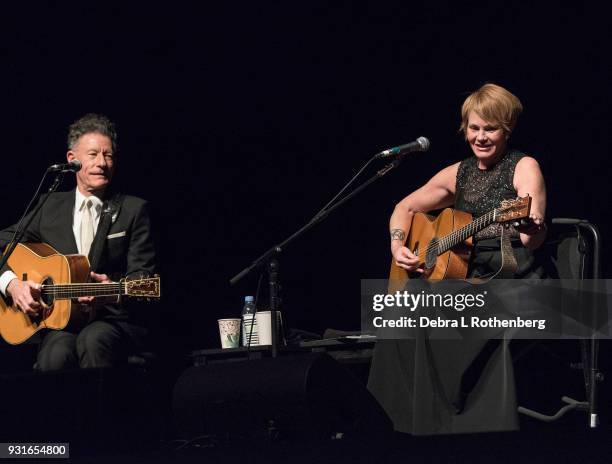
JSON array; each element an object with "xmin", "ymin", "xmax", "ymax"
[{"xmin": 173, "ymin": 353, "xmax": 392, "ymax": 439}]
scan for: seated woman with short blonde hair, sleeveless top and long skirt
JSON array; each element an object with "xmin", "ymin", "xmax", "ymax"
[{"xmin": 368, "ymin": 84, "xmax": 546, "ymax": 434}]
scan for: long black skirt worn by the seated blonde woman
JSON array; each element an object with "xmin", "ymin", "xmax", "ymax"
[{"xmin": 368, "ymin": 242, "xmax": 543, "ymax": 435}]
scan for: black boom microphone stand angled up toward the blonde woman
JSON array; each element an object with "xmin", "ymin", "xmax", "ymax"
[{"xmin": 230, "ymin": 154, "xmax": 404, "ymax": 358}]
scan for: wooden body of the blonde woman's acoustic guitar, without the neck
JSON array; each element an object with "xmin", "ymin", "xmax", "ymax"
[{"xmin": 389, "ymin": 208, "xmax": 472, "ymax": 292}]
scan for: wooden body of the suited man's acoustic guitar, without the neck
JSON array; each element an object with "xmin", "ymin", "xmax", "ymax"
[{"xmin": 0, "ymin": 243, "xmax": 89, "ymax": 345}]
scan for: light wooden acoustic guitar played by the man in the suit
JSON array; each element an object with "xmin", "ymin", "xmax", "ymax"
[{"xmin": 0, "ymin": 243, "xmax": 160, "ymax": 345}]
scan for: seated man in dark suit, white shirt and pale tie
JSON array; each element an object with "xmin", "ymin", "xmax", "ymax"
[{"xmin": 0, "ymin": 114, "xmax": 155, "ymax": 371}]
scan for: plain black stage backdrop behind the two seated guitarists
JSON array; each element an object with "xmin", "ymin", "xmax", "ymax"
[{"xmin": 0, "ymin": 1, "xmax": 612, "ymax": 351}]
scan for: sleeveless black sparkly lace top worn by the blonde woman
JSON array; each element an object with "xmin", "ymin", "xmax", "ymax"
[{"xmin": 455, "ymin": 150, "xmax": 526, "ymax": 240}]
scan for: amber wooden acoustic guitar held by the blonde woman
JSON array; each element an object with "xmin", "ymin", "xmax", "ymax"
[{"xmin": 389, "ymin": 195, "xmax": 531, "ymax": 289}]
